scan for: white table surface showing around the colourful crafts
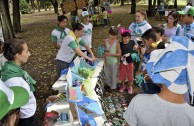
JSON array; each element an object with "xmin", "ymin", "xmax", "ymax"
[{"xmin": 47, "ymin": 58, "xmax": 107, "ymax": 126}]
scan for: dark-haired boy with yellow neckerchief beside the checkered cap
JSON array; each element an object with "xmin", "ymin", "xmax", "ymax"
[{"xmin": 136, "ymin": 29, "xmax": 160, "ymax": 94}]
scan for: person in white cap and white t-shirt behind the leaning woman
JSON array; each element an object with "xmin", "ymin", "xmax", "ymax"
[{"xmin": 80, "ymin": 11, "xmax": 93, "ymax": 54}]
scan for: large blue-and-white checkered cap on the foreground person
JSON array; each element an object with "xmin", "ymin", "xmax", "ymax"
[{"xmin": 146, "ymin": 36, "xmax": 194, "ymax": 96}]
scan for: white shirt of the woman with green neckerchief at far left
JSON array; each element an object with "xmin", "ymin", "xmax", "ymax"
[{"xmin": 4, "ymin": 77, "xmax": 36, "ymax": 118}]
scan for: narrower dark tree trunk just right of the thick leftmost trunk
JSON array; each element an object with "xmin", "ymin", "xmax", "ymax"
[{"xmin": 13, "ymin": 0, "xmax": 21, "ymax": 33}]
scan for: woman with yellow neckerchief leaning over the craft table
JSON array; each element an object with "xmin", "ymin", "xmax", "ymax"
[{"xmin": 56, "ymin": 23, "xmax": 96, "ymax": 77}]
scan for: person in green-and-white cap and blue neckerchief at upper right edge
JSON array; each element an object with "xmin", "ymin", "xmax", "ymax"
[{"xmin": 178, "ymin": 6, "xmax": 194, "ymax": 41}]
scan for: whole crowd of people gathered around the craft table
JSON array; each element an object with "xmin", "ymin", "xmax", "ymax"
[{"xmin": 0, "ymin": 2, "xmax": 194, "ymax": 126}]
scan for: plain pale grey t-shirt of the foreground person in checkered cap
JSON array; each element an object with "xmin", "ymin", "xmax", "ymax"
[{"xmin": 123, "ymin": 94, "xmax": 194, "ymax": 126}]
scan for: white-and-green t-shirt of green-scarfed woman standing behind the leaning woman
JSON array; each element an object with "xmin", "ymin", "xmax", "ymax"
[{"xmin": 51, "ymin": 28, "xmax": 70, "ymax": 46}]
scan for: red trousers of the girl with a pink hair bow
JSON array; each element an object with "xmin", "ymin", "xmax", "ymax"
[{"xmin": 119, "ymin": 63, "xmax": 134, "ymax": 82}]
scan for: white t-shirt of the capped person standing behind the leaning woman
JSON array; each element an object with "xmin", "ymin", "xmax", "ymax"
[{"xmin": 80, "ymin": 23, "xmax": 92, "ymax": 50}]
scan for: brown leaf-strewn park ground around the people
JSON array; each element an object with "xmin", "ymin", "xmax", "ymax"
[{"xmin": 17, "ymin": 5, "xmax": 171, "ymax": 126}]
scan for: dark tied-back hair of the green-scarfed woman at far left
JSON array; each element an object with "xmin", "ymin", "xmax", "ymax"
[{"xmin": 3, "ymin": 39, "xmax": 25, "ymax": 60}]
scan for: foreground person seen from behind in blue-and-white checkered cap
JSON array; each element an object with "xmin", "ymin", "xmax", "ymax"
[{"xmin": 123, "ymin": 36, "xmax": 194, "ymax": 126}]
